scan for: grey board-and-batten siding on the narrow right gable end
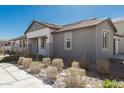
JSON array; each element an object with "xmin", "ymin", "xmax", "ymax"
[{"xmin": 96, "ymin": 22, "xmax": 114, "ymax": 58}]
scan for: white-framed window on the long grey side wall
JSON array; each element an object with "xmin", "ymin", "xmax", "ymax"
[{"xmin": 64, "ymin": 32, "xmax": 72, "ymax": 50}]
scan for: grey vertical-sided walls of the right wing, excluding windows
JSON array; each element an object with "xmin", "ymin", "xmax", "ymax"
[{"xmin": 53, "ymin": 22, "xmax": 114, "ymax": 62}]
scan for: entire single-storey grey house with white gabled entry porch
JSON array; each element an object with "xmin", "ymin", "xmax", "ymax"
[{"xmin": 24, "ymin": 18, "xmax": 120, "ymax": 61}]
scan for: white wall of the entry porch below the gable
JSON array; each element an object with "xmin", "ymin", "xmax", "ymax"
[{"xmin": 26, "ymin": 28, "xmax": 53, "ymax": 57}]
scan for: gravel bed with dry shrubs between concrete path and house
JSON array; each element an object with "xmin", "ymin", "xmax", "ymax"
[{"xmin": 0, "ymin": 51, "xmax": 124, "ymax": 88}]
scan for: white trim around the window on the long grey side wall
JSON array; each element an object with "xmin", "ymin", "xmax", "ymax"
[{"xmin": 64, "ymin": 32, "xmax": 72, "ymax": 50}]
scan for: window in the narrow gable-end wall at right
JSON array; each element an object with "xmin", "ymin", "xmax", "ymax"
[{"xmin": 103, "ymin": 32, "xmax": 110, "ymax": 49}]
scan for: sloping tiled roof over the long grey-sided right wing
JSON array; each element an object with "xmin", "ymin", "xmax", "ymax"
[{"xmin": 53, "ymin": 17, "xmax": 117, "ymax": 33}]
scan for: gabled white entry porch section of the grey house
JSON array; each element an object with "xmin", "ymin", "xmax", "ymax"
[{"xmin": 24, "ymin": 21, "xmax": 61, "ymax": 57}]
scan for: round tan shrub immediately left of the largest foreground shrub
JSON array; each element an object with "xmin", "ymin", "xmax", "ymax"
[{"xmin": 47, "ymin": 66, "xmax": 58, "ymax": 81}]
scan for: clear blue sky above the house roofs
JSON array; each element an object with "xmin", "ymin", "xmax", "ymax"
[{"xmin": 0, "ymin": 5, "xmax": 124, "ymax": 39}]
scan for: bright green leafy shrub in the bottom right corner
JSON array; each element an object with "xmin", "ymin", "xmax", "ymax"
[{"xmin": 102, "ymin": 79, "xmax": 121, "ymax": 88}]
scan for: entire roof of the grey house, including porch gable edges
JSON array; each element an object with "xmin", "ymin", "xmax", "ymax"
[{"xmin": 24, "ymin": 17, "xmax": 117, "ymax": 34}]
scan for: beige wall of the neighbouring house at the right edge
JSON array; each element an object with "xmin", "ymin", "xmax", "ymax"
[{"xmin": 114, "ymin": 21, "xmax": 124, "ymax": 54}]
